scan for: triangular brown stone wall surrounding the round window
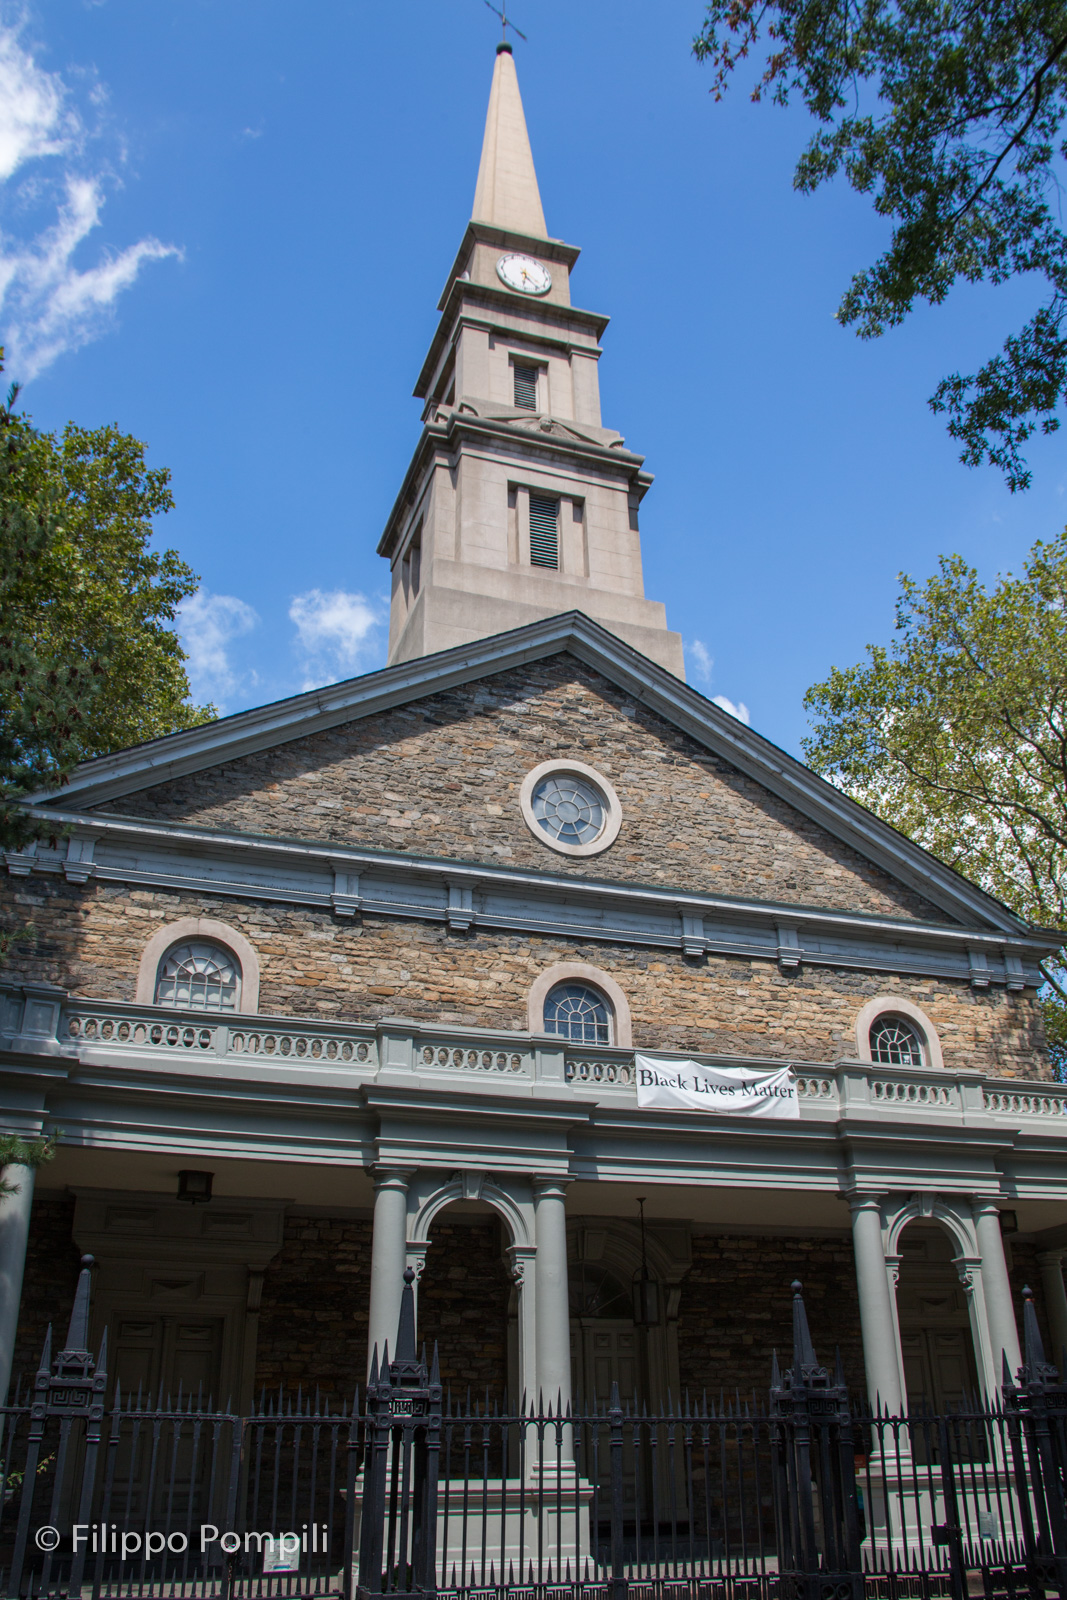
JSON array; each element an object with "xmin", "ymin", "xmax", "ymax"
[{"xmin": 91, "ymin": 654, "xmax": 947, "ymax": 922}]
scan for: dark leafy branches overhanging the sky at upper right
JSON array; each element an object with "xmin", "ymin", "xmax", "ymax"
[{"xmin": 694, "ymin": 0, "xmax": 1067, "ymax": 491}]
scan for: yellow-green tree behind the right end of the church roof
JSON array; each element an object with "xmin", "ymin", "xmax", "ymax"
[{"xmin": 805, "ymin": 531, "xmax": 1067, "ymax": 1069}]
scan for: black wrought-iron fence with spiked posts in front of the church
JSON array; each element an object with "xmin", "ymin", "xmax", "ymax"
[{"xmin": 0, "ymin": 1270, "xmax": 1067, "ymax": 1600}]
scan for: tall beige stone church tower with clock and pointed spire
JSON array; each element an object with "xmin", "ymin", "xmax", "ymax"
[{"xmin": 378, "ymin": 45, "xmax": 685, "ymax": 677}]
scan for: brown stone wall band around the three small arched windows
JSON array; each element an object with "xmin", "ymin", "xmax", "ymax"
[{"xmin": 0, "ymin": 877, "xmax": 1049, "ymax": 1077}]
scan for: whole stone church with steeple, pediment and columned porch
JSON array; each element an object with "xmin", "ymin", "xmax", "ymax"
[{"xmin": 0, "ymin": 45, "xmax": 1067, "ymax": 1411}]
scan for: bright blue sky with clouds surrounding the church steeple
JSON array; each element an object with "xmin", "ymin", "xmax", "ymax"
[{"xmin": 0, "ymin": 0, "xmax": 1067, "ymax": 752}]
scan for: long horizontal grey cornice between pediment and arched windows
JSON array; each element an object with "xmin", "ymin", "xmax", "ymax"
[{"xmin": 6, "ymin": 796, "xmax": 1056, "ymax": 989}]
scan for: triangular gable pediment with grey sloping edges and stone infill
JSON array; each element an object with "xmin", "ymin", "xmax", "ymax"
[{"xmin": 24, "ymin": 613, "xmax": 1025, "ymax": 934}]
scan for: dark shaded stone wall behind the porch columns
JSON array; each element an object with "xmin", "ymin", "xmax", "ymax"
[{"xmin": 14, "ymin": 1190, "xmax": 1053, "ymax": 1405}]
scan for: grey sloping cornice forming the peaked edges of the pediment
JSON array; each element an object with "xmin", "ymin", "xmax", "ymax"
[{"xmin": 18, "ymin": 611, "xmax": 1043, "ymax": 950}]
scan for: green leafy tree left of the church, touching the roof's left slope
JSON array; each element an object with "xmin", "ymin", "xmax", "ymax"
[{"xmin": 0, "ymin": 355, "xmax": 214, "ymax": 846}]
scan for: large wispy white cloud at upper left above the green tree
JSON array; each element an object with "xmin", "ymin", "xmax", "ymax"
[{"xmin": 0, "ymin": 22, "xmax": 181, "ymax": 382}]
